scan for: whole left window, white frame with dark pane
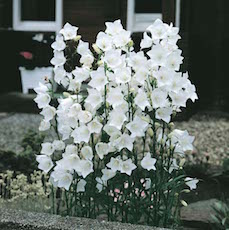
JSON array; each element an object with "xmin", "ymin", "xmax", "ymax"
[{"xmin": 13, "ymin": 0, "xmax": 63, "ymax": 32}]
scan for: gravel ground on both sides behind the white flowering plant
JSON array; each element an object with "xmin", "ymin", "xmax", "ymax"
[{"xmin": 0, "ymin": 113, "xmax": 229, "ymax": 164}]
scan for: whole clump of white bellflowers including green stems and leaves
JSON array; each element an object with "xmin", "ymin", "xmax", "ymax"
[{"xmin": 35, "ymin": 20, "xmax": 198, "ymax": 226}]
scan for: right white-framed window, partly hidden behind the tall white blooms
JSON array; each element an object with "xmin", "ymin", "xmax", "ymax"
[{"xmin": 127, "ymin": 0, "xmax": 162, "ymax": 32}]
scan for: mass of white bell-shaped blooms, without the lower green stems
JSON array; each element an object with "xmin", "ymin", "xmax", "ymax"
[{"xmin": 35, "ymin": 20, "xmax": 197, "ymax": 226}]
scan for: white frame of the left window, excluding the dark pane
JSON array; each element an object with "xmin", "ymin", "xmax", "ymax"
[{"xmin": 13, "ymin": 0, "xmax": 63, "ymax": 33}]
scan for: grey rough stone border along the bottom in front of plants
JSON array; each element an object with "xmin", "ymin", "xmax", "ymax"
[{"xmin": 0, "ymin": 208, "xmax": 168, "ymax": 230}]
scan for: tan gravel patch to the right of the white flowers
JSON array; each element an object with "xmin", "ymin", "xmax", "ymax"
[{"xmin": 175, "ymin": 115, "xmax": 229, "ymax": 165}]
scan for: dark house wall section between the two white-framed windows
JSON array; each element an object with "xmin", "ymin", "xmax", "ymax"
[{"xmin": 64, "ymin": 0, "xmax": 127, "ymax": 43}]
